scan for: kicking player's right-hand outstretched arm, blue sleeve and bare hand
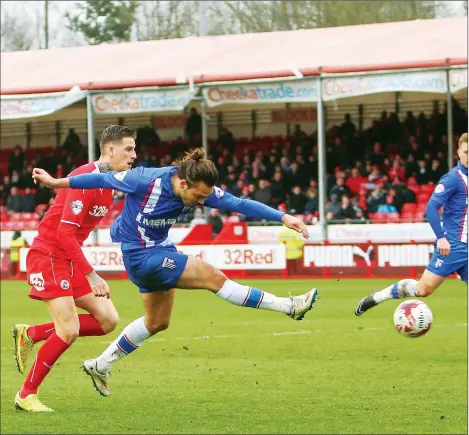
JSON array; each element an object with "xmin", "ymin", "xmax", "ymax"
[{"xmin": 205, "ymin": 187, "xmax": 309, "ymax": 239}]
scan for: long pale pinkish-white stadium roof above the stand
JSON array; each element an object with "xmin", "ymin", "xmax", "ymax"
[{"xmin": 1, "ymin": 17, "xmax": 467, "ymax": 95}]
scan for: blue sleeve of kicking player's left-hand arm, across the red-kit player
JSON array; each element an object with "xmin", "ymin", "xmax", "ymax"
[{"xmin": 69, "ymin": 167, "xmax": 143, "ymax": 193}]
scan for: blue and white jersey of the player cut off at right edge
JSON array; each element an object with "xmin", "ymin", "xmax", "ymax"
[{"xmin": 430, "ymin": 162, "xmax": 468, "ymax": 243}]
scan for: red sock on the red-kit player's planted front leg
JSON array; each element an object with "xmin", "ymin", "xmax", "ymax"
[{"xmin": 20, "ymin": 332, "xmax": 70, "ymax": 399}]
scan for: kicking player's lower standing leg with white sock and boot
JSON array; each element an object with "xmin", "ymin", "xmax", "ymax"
[{"xmin": 82, "ymin": 289, "xmax": 175, "ymax": 396}]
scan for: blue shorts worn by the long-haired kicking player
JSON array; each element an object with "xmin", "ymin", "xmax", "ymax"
[{"xmin": 122, "ymin": 246, "xmax": 188, "ymax": 293}]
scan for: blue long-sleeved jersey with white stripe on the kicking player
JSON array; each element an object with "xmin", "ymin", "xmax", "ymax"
[{"xmin": 70, "ymin": 166, "xmax": 284, "ymax": 252}]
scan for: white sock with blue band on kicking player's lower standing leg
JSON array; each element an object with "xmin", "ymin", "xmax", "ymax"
[{"xmin": 96, "ymin": 317, "xmax": 151, "ymax": 373}]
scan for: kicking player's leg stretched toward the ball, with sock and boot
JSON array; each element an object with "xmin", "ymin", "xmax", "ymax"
[{"xmin": 177, "ymin": 254, "xmax": 319, "ymax": 320}]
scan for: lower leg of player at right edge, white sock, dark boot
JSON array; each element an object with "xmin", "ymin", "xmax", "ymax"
[{"xmin": 355, "ymin": 269, "xmax": 445, "ymax": 316}]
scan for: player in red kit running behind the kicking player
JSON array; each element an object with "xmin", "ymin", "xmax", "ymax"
[{"xmin": 13, "ymin": 125, "xmax": 136, "ymax": 412}]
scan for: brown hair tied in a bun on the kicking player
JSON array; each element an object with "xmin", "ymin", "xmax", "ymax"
[{"xmin": 172, "ymin": 148, "xmax": 218, "ymax": 187}]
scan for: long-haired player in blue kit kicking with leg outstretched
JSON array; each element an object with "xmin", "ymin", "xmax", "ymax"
[{"xmin": 33, "ymin": 148, "xmax": 318, "ymax": 396}]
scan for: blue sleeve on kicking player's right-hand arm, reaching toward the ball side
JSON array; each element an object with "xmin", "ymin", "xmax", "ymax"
[{"xmin": 205, "ymin": 187, "xmax": 284, "ymax": 222}]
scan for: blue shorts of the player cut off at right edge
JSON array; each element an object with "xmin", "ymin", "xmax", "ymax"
[{"xmin": 427, "ymin": 241, "xmax": 468, "ymax": 283}]
